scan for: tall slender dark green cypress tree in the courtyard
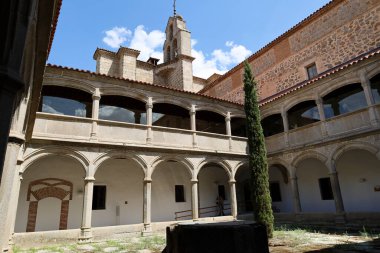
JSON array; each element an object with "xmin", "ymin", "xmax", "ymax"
[{"xmin": 244, "ymin": 62, "xmax": 274, "ymax": 237}]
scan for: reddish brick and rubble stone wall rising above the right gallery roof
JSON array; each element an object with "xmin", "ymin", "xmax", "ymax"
[{"xmin": 205, "ymin": 0, "xmax": 380, "ymax": 102}]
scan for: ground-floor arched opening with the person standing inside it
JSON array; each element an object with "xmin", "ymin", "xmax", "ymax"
[{"xmin": 198, "ymin": 162, "xmax": 231, "ymax": 218}]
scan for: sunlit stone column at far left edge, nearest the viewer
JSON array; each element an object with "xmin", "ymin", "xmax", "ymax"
[{"xmin": 0, "ymin": 137, "xmax": 24, "ymax": 252}]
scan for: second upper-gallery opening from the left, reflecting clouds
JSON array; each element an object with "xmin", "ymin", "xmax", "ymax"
[{"xmin": 99, "ymin": 96, "xmax": 146, "ymax": 124}]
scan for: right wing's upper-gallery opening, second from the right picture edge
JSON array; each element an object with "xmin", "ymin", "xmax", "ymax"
[{"xmin": 323, "ymin": 83, "xmax": 367, "ymax": 118}]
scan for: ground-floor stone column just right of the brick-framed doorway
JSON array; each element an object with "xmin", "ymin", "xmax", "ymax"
[{"xmin": 79, "ymin": 177, "xmax": 95, "ymax": 241}]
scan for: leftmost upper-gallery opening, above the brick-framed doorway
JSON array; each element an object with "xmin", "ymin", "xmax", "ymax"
[{"xmin": 39, "ymin": 85, "xmax": 92, "ymax": 118}]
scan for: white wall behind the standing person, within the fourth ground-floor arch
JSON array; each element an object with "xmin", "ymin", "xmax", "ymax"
[{"xmin": 198, "ymin": 166, "xmax": 231, "ymax": 217}]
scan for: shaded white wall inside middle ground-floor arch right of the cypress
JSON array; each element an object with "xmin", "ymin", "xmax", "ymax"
[{"xmin": 296, "ymin": 159, "xmax": 335, "ymax": 212}]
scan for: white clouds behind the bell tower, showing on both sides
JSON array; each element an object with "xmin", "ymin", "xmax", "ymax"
[{"xmin": 103, "ymin": 25, "xmax": 252, "ymax": 78}]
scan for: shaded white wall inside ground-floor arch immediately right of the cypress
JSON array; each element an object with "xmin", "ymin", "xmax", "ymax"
[{"xmin": 269, "ymin": 166, "xmax": 293, "ymax": 213}]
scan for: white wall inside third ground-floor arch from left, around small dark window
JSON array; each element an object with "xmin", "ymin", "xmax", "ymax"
[{"xmin": 152, "ymin": 161, "xmax": 192, "ymax": 222}]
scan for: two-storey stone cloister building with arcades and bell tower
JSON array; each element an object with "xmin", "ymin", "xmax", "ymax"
[{"xmin": 0, "ymin": 0, "xmax": 380, "ymax": 250}]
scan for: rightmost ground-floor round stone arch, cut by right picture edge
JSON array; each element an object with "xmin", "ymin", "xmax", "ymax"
[{"xmin": 330, "ymin": 142, "xmax": 380, "ymax": 169}]
